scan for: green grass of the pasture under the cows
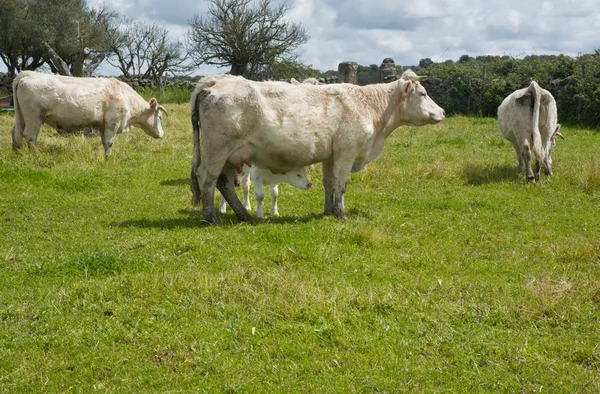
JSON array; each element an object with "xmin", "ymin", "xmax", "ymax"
[{"xmin": 0, "ymin": 104, "xmax": 600, "ymax": 393}]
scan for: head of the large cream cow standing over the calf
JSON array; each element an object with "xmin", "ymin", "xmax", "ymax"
[{"xmin": 398, "ymin": 76, "xmax": 446, "ymax": 126}]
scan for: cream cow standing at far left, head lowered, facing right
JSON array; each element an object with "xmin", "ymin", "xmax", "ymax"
[{"xmin": 12, "ymin": 71, "xmax": 167, "ymax": 158}]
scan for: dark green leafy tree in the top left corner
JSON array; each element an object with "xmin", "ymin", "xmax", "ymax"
[{"xmin": 0, "ymin": 0, "xmax": 116, "ymax": 76}]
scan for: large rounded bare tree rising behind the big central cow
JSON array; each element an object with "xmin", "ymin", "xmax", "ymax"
[{"xmin": 187, "ymin": 0, "xmax": 309, "ymax": 78}]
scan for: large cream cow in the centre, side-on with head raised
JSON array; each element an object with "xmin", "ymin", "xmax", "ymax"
[{"xmin": 191, "ymin": 72, "xmax": 444, "ymax": 222}]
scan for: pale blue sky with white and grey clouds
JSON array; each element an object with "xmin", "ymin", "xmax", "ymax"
[{"xmin": 3, "ymin": 0, "xmax": 600, "ymax": 75}]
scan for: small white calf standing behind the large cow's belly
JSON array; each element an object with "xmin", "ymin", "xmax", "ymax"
[{"xmin": 219, "ymin": 164, "xmax": 312, "ymax": 218}]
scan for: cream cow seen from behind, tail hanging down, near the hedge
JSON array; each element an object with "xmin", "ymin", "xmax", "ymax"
[{"xmin": 498, "ymin": 81, "xmax": 564, "ymax": 182}]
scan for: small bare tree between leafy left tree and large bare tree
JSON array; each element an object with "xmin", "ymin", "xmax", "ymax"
[{"xmin": 109, "ymin": 20, "xmax": 193, "ymax": 88}]
